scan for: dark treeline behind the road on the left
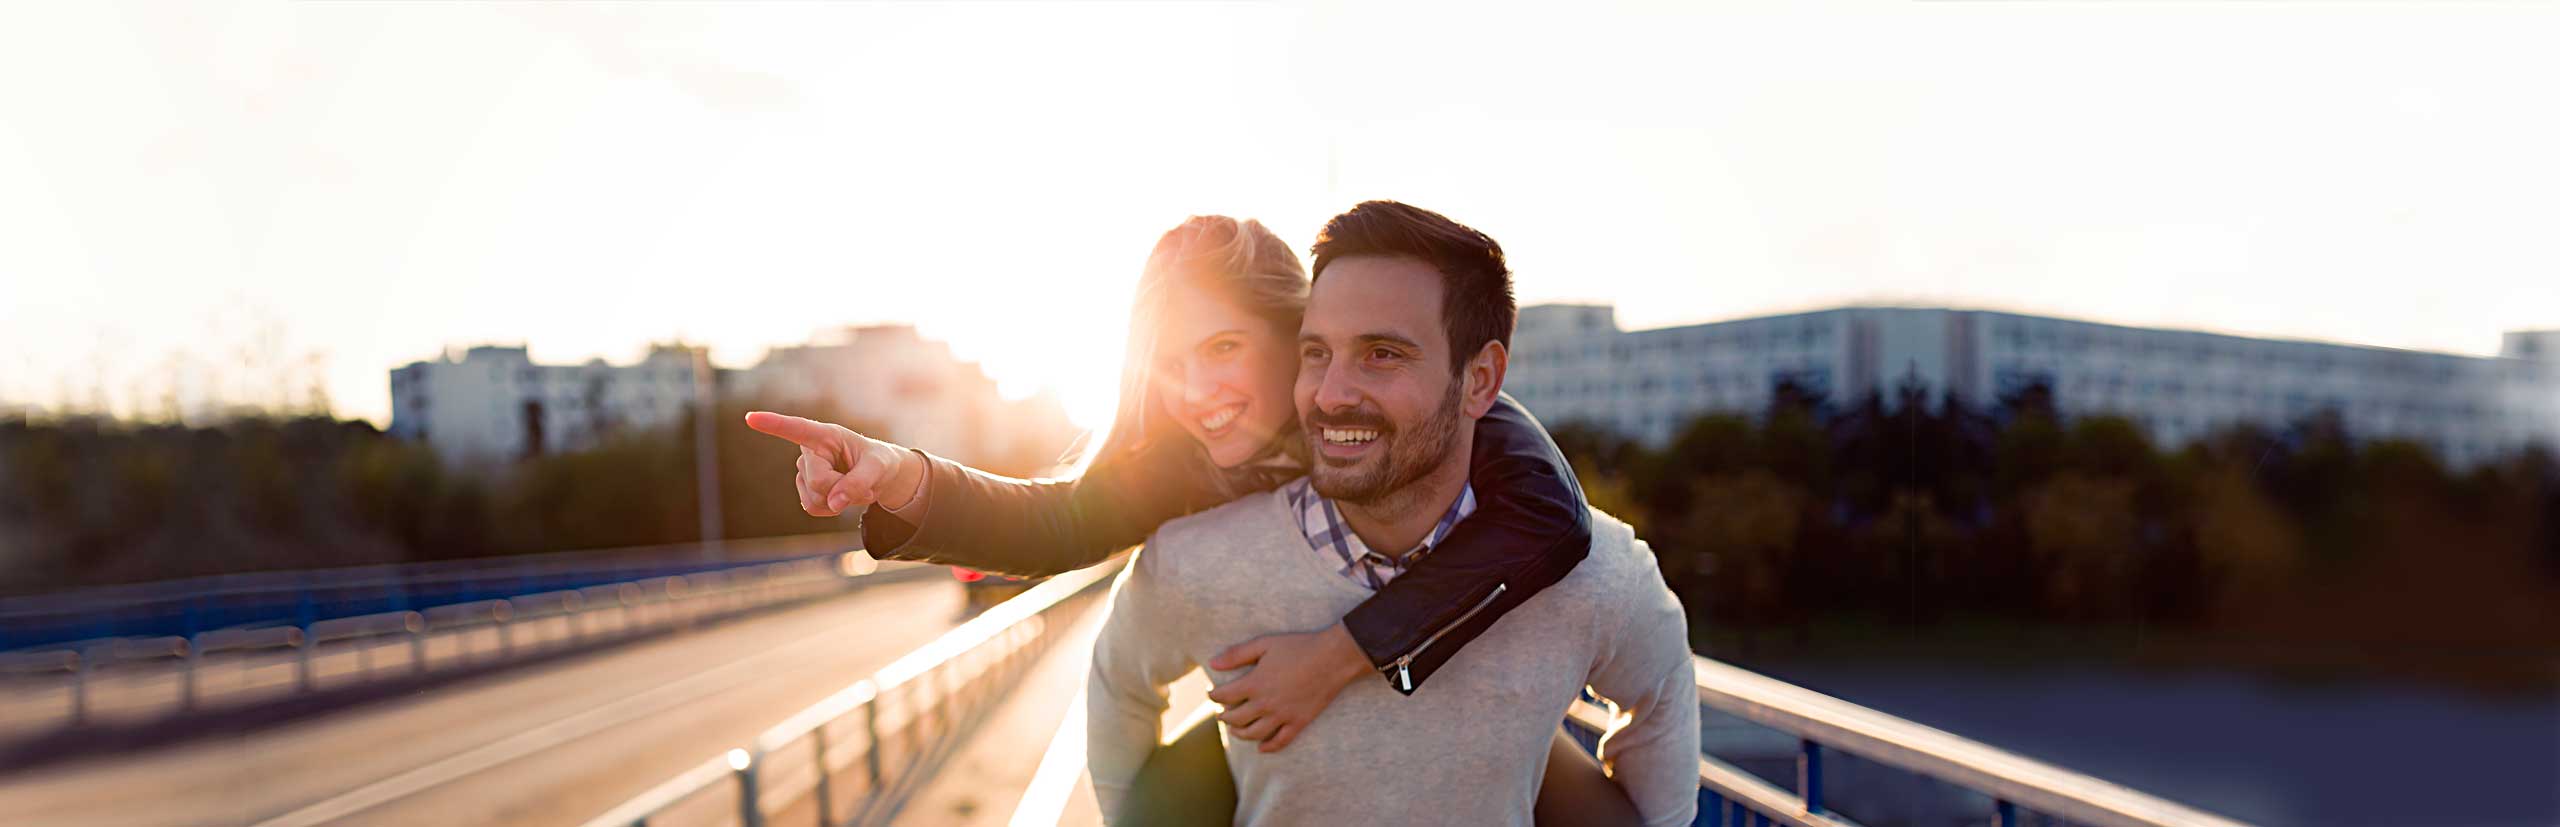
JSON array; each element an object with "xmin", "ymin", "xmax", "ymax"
[{"xmin": 0, "ymin": 402, "xmax": 1065, "ymax": 594}]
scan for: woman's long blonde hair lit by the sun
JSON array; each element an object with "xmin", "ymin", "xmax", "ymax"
[{"xmin": 1078, "ymin": 215, "xmax": 1308, "ymax": 499}]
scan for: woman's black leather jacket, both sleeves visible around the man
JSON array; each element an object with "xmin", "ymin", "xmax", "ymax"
[{"xmin": 863, "ymin": 394, "xmax": 1592, "ymax": 694}]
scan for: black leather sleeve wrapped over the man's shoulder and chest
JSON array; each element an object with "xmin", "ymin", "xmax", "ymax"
[{"xmin": 1341, "ymin": 394, "xmax": 1592, "ymax": 694}]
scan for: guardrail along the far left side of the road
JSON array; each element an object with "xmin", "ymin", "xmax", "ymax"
[{"xmin": 0, "ymin": 550, "xmax": 940, "ymax": 743}]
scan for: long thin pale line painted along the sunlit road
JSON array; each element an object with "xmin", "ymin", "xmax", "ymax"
[{"xmin": 251, "ymin": 583, "xmax": 942, "ymax": 827}]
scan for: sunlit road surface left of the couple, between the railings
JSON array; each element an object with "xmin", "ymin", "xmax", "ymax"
[{"xmin": 0, "ymin": 579, "xmax": 963, "ymax": 827}]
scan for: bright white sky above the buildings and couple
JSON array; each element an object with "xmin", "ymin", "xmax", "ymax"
[{"xmin": 0, "ymin": 3, "xmax": 2560, "ymax": 425}]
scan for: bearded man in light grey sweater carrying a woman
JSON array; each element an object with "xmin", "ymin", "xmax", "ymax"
[{"xmin": 1085, "ymin": 202, "xmax": 1697, "ymax": 824}]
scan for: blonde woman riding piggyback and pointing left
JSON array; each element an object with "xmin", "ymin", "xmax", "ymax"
[{"xmin": 748, "ymin": 215, "xmax": 1631, "ymax": 817}]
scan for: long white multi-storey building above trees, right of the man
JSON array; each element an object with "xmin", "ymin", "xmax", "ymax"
[{"xmin": 1505, "ymin": 305, "xmax": 2560, "ymax": 466}]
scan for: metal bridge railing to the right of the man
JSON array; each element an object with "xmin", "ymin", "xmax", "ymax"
[{"xmin": 1564, "ymin": 658, "xmax": 2245, "ymax": 827}]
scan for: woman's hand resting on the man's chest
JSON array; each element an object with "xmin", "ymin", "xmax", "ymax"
[{"xmin": 1208, "ymin": 622, "xmax": 1370, "ymax": 753}]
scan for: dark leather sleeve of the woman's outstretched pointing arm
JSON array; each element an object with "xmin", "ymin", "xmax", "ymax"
[{"xmin": 863, "ymin": 440, "xmax": 1216, "ymax": 576}]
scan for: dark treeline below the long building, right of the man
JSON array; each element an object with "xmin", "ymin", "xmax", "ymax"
[{"xmin": 1556, "ymin": 387, "xmax": 2560, "ymax": 681}]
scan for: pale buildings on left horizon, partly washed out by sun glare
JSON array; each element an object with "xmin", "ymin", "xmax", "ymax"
[{"xmin": 389, "ymin": 325, "xmax": 1073, "ymax": 469}]
